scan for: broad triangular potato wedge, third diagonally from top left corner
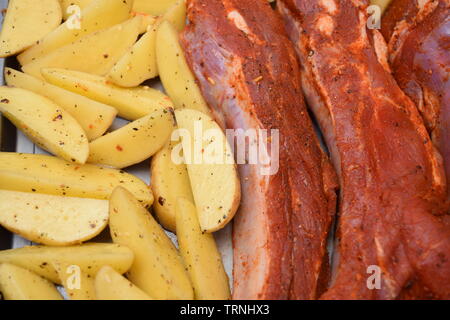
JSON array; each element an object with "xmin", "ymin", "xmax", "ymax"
[{"xmin": 22, "ymin": 17, "xmax": 142, "ymax": 79}]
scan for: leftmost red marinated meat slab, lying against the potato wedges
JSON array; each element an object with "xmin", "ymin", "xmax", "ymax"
[{"xmin": 181, "ymin": 0, "xmax": 337, "ymax": 299}]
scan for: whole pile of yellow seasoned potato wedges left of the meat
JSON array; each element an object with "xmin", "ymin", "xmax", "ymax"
[{"xmin": 0, "ymin": 0, "xmax": 240, "ymax": 300}]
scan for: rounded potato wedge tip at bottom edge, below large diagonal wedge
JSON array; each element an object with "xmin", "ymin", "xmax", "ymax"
[{"xmin": 95, "ymin": 266, "xmax": 153, "ymax": 300}]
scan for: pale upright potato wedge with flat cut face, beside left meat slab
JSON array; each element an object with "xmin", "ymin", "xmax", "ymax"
[{"xmin": 175, "ymin": 109, "xmax": 241, "ymax": 232}]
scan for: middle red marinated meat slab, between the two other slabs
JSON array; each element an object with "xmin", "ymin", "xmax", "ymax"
[{"xmin": 277, "ymin": 0, "xmax": 450, "ymax": 299}]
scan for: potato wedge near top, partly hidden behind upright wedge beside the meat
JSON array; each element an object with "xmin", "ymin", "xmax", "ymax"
[{"xmin": 107, "ymin": 0, "xmax": 186, "ymax": 87}]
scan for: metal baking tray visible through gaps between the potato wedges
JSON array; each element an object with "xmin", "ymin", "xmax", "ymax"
[{"xmin": 0, "ymin": 0, "xmax": 233, "ymax": 295}]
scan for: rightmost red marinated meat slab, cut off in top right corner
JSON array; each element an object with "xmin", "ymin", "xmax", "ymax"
[{"xmin": 381, "ymin": 0, "xmax": 450, "ymax": 195}]
